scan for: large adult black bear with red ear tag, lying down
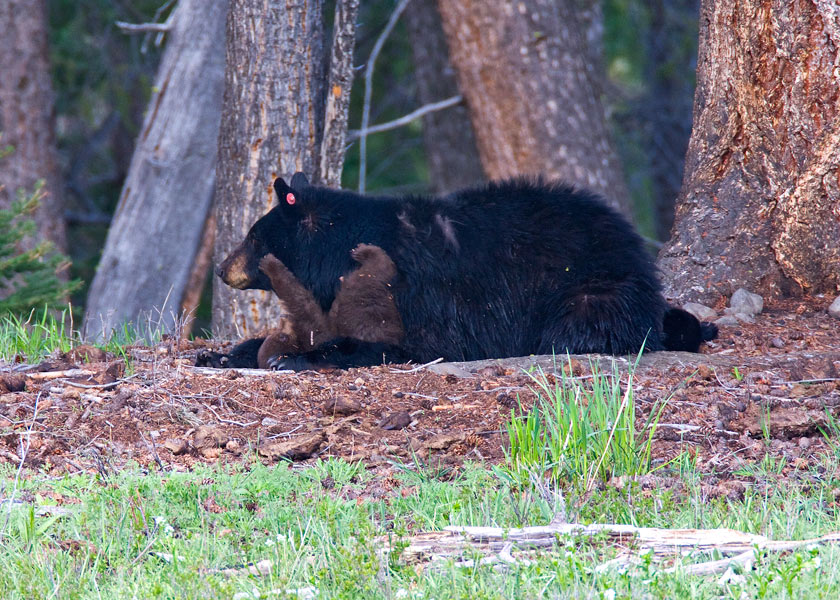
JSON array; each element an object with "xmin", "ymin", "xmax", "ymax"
[{"xmin": 203, "ymin": 173, "xmax": 709, "ymax": 368}]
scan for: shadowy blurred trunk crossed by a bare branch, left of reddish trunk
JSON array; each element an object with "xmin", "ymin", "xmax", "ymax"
[{"xmin": 405, "ymin": 0, "xmax": 484, "ymax": 192}]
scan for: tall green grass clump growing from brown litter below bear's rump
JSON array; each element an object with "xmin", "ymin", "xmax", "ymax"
[{"xmin": 506, "ymin": 358, "xmax": 667, "ymax": 490}]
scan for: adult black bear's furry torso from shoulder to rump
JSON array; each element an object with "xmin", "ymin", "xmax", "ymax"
[{"xmin": 378, "ymin": 180, "xmax": 664, "ymax": 360}]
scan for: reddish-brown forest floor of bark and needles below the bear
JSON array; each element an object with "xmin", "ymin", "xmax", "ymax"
[{"xmin": 0, "ymin": 298, "xmax": 840, "ymax": 501}]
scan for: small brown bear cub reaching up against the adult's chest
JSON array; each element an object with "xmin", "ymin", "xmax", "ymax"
[{"xmin": 257, "ymin": 244, "xmax": 404, "ymax": 369}]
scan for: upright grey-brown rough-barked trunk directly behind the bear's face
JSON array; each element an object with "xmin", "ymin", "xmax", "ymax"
[{"xmin": 213, "ymin": 0, "xmax": 324, "ymax": 339}]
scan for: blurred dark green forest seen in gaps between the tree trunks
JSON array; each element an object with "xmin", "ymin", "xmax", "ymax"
[{"xmin": 0, "ymin": 0, "xmax": 736, "ymax": 334}]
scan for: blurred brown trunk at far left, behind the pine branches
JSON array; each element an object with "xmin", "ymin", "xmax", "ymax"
[{"xmin": 0, "ymin": 0, "xmax": 66, "ymax": 250}]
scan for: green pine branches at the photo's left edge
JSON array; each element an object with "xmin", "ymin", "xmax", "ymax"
[{"xmin": 0, "ymin": 181, "xmax": 81, "ymax": 314}]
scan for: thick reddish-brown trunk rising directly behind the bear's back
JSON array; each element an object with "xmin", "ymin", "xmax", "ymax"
[{"xmin": 438, "ymin": 0, "xmax": 629, "ymax": 212}]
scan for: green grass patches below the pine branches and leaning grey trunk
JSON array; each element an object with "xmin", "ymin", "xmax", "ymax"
[{"xmin": 0, "ymin": 308, "xmax": 160, "ymax": 363}]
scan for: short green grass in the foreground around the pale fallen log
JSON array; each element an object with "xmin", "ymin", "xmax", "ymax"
[{"xmin": 0, "ymin": 460, "xmax": 840, "ymax": 600}]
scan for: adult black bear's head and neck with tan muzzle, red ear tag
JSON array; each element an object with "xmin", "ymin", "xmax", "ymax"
[{"xmin": 216, "ymin": 172, "xmax": 357, "ymax": 306}]
